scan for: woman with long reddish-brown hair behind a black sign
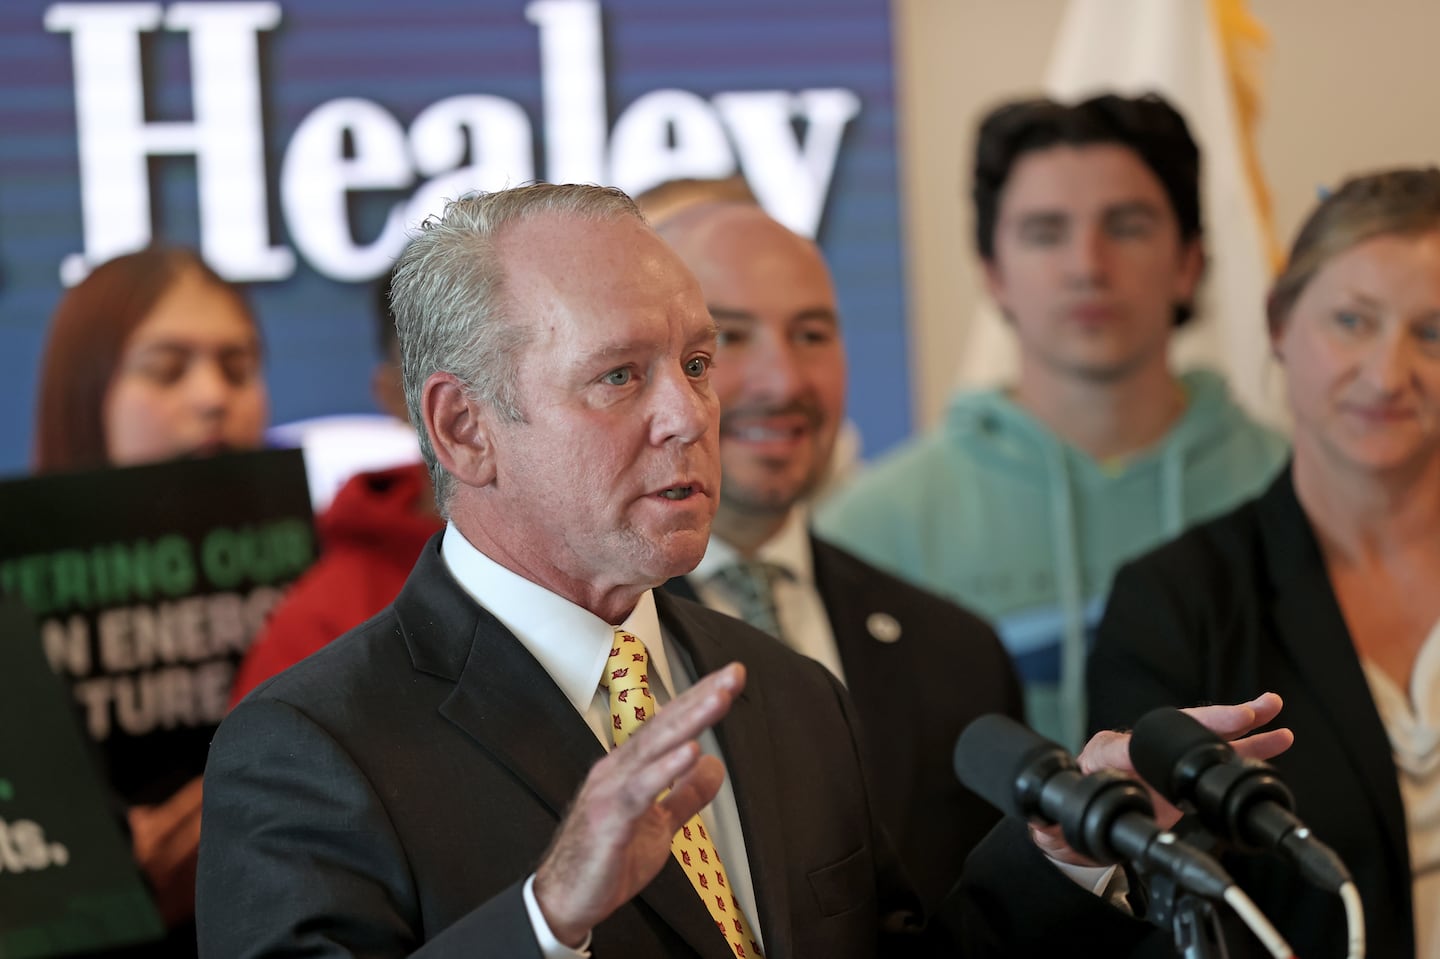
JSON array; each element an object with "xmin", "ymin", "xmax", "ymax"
[{"xmin": 35, "ymin": 246, "xmax": 268, "ymax": 956}]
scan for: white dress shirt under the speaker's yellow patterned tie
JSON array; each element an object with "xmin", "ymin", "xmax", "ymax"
[{"xmin": 441, "ymin": 524, "xmax": 765, "ymax": 959}]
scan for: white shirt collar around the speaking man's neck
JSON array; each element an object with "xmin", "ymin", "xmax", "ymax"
[{"xmin": 441, "ymin": 523, "xmax": 675, "ymax": 716}]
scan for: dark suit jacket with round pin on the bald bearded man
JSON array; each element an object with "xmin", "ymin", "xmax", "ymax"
[{"xmin": 665, "ymin": 537, "xmax": 1024, "ymax": 909}]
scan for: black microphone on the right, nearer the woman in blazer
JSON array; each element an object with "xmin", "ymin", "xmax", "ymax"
[{"xmin": 1130, "ymin": 707, "xmax": 1349, "ymax": 891}]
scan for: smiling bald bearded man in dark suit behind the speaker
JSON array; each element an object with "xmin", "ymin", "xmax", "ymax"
[{"xmin": 658, "ymin": 202, "xmax": 1024, "ymax": 906}]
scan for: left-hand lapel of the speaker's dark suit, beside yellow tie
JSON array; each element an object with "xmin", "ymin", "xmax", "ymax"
[{"xmin": 395, "ymin": 537, "xmax": 733, "ymax": 959}]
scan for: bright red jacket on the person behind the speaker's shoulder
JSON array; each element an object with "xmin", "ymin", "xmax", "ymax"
[{"xmin": 230, "ymin": 464, "xmax": 444, "ymax": 706}]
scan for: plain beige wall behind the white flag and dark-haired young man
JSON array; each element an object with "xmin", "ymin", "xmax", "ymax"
[{"xmin": 893, "ymin": 0, "xmax": 1440, "ymax": 425}]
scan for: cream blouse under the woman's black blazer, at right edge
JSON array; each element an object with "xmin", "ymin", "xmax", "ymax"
[{"xmin": 1361, "ymin": 622, "xmax": 1440, "ymax": 956}]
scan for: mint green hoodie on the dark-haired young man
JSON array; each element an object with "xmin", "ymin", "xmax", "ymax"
[{"xmin": 815, "ymin": 370, "xmax": 1286, "ymax": 749}]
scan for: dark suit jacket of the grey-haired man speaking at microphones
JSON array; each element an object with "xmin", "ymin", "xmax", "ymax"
[{"xmin": 197, "ymin": 537, "xmax": 1138, "ymax": 959}]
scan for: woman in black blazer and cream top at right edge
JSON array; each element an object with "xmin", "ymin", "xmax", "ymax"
[{"xmin": 1089, "ymin": 167, "xmax": 1440, "ymax": 958}]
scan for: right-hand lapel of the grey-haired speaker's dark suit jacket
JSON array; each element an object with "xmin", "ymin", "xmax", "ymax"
[{"xmin": 655, "ymin": 593, "xmax": 795, "ymax": 959}]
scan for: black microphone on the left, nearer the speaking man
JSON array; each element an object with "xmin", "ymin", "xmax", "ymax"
[{"xmin": 955, "ymin": 713, "xmax": 1234, "ymax": 900}]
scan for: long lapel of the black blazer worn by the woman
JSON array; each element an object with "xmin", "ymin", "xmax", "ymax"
[{"xmin": 1259, "ymin": 469, "xmax": 1410, "ymax": 875}]
